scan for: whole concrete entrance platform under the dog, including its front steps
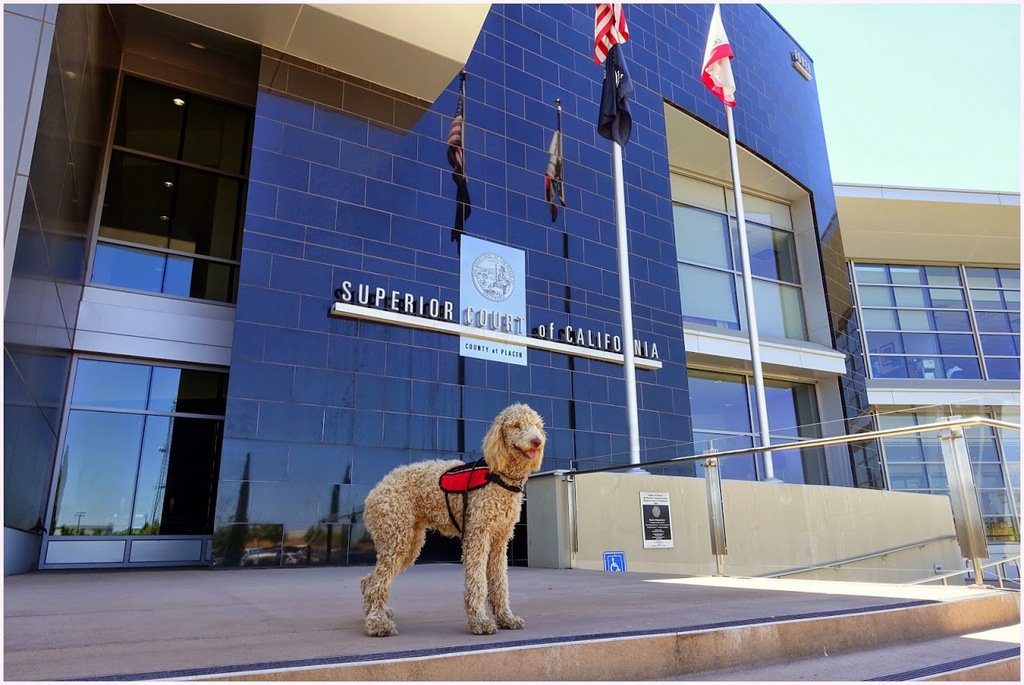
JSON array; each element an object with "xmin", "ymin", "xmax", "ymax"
[{"xmin": 4, "ymin": 564, "xmax": 1020, "ymax": 681}]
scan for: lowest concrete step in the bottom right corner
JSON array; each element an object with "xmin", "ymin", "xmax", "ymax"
[{"xmin": 664, "ymin": 624, "xmax": 1020, "ymax": 682}]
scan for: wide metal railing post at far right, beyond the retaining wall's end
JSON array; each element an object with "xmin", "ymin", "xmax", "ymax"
[{"xmin": 939, "ymin": 417, "xmax": 988, "ymax": 586}]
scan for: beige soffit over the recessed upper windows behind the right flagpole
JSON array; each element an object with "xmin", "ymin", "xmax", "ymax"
[{"xmin": 665, "ymin": 103, "xmax": 807, "ymax": 202}]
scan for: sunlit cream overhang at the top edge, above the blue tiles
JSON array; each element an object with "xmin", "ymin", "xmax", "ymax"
[{"xmin": 144, "ymin": 3, "xmax": 490, "ymax": 102}]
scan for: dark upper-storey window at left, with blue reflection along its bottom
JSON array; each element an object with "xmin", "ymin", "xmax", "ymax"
[{"xmin": 91, "ymin": 77, "xmax": 252, "ymax": 302}]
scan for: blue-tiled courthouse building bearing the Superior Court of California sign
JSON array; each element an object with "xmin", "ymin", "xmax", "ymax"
[{"xmin": 4, "ymin": 4, "xmax": 937, "ymax": 573}]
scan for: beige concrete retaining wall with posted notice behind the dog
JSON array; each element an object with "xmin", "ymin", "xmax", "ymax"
[{"xmin": 526, "ymin": 473, "xmax": 963, "ymax": 583}]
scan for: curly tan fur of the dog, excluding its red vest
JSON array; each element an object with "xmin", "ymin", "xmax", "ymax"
[{"xmin": 359, "ymin": 404, "xmax": 547, "ymax": 637}]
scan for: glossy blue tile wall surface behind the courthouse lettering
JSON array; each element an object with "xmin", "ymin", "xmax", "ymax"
[{"xmin": 214, "ymin": 4, "xmax": 848, "ymax": 563}]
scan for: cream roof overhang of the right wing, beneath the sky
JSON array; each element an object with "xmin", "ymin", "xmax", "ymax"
[{"xmin": 835, "ymin": 183, "xmax": 1021, "ymax": 266}]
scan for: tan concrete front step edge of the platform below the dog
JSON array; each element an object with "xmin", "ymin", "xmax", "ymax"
[{"xmin": 190, "ymin": 579, "xmax": 1020, "ymax": 681}]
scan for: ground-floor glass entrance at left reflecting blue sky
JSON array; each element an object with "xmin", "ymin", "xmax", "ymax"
[{"xmin": 40, "ymin": 358, "xmax": 227, "ymax": 567}]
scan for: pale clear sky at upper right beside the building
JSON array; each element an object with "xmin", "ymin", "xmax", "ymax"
[{"xmin": 761, "ymin": 3, "xmax": 1021, "ymax": 192}]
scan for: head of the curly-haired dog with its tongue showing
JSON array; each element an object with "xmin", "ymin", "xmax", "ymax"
[{"xmin": 483, "ymin": 404, "xmax": 548, "ymax": 478}]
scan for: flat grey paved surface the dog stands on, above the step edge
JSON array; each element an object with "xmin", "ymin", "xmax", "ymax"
[{"xmin": 3, "ymin": 564, "xmax": 1007, "ymax": 681}]
